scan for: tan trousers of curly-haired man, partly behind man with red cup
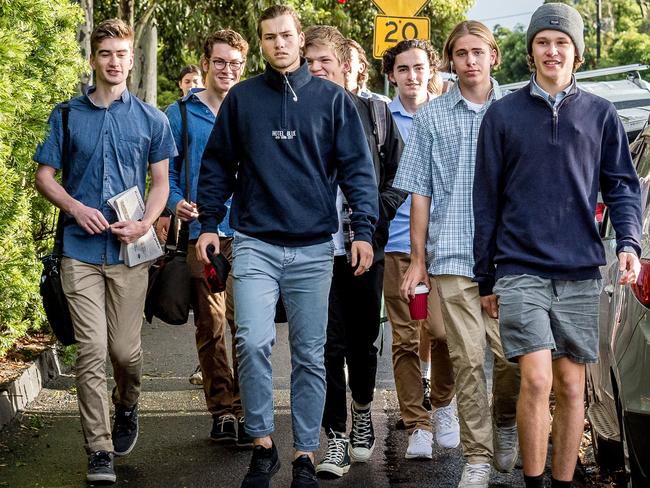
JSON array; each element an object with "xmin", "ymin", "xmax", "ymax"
[{"xmin": 384, "ymin": 252, "xmax": 454, "ymax": 432}]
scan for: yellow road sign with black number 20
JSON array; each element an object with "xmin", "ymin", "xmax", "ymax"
[{"xmin": 372, "ymin": 0, "xmax": 431, "ymax": 59}]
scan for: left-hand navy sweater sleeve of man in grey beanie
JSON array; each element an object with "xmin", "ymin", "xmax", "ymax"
[{"xmin": 472, "ymin": 107, "xmax": 503, "ymax": 296}]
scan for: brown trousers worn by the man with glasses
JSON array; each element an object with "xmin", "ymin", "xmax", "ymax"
[{"xmin": 187, "ymin": 238, "xmax": 243, "ymax": 417}]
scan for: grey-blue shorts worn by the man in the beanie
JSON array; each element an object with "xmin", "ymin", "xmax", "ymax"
[{"xmin": 494, "ymin": 275, "xmax": 602, "ymax": 364}]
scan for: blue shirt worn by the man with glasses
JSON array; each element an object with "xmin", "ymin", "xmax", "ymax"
[{"xmin": 165, "ymin": 88, "xmax": 234, "ymax": 239}]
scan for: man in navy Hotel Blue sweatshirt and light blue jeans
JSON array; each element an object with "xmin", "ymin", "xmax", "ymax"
[{"xmin": 196, "ymin": 5, "xmax": 378, "ymax": 488}]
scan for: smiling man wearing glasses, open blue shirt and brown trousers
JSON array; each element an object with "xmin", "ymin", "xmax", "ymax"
[{"xmin": 166, "ymin": 29, "xmax": 252, "ymax": 447}]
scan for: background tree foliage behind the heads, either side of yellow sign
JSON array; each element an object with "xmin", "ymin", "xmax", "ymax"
[{"xmin": 95, "ymin": 0, "xmax": 474, "ymax": 106}]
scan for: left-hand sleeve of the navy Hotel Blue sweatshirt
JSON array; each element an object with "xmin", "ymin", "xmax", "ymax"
[{"xmin": 196, "ymin": 93, "xmax": 240, "ymax": 234}]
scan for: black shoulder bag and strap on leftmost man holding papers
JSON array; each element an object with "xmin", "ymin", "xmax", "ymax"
[{"xmin": 39, "ymin": 103, "xmax": 77, "ymax": 346}]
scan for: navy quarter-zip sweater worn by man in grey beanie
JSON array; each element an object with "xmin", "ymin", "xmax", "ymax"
[{"xmin": 473, "ymin": 84, "xmax": 641, "ymax": 296}]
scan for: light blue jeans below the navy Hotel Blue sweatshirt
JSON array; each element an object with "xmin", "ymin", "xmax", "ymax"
[{"xmin": 232, "ymin": 232, "xmax": 334, "ymax": 452}]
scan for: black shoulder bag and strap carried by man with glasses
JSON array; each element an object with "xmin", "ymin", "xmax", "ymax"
[{"xmin": 144, "ymin": 100, "xmax": 192, "ymax": 325}]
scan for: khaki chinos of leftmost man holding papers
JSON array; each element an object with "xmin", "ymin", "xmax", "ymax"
[{"xmin": 61, "ymin": 258, "xmax": 149, "ymax": 453}]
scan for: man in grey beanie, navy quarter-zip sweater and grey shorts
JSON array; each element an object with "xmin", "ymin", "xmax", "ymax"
[{"xmin": 473, "ymin": 3, "xmax": 641, "ymax": 488}]
